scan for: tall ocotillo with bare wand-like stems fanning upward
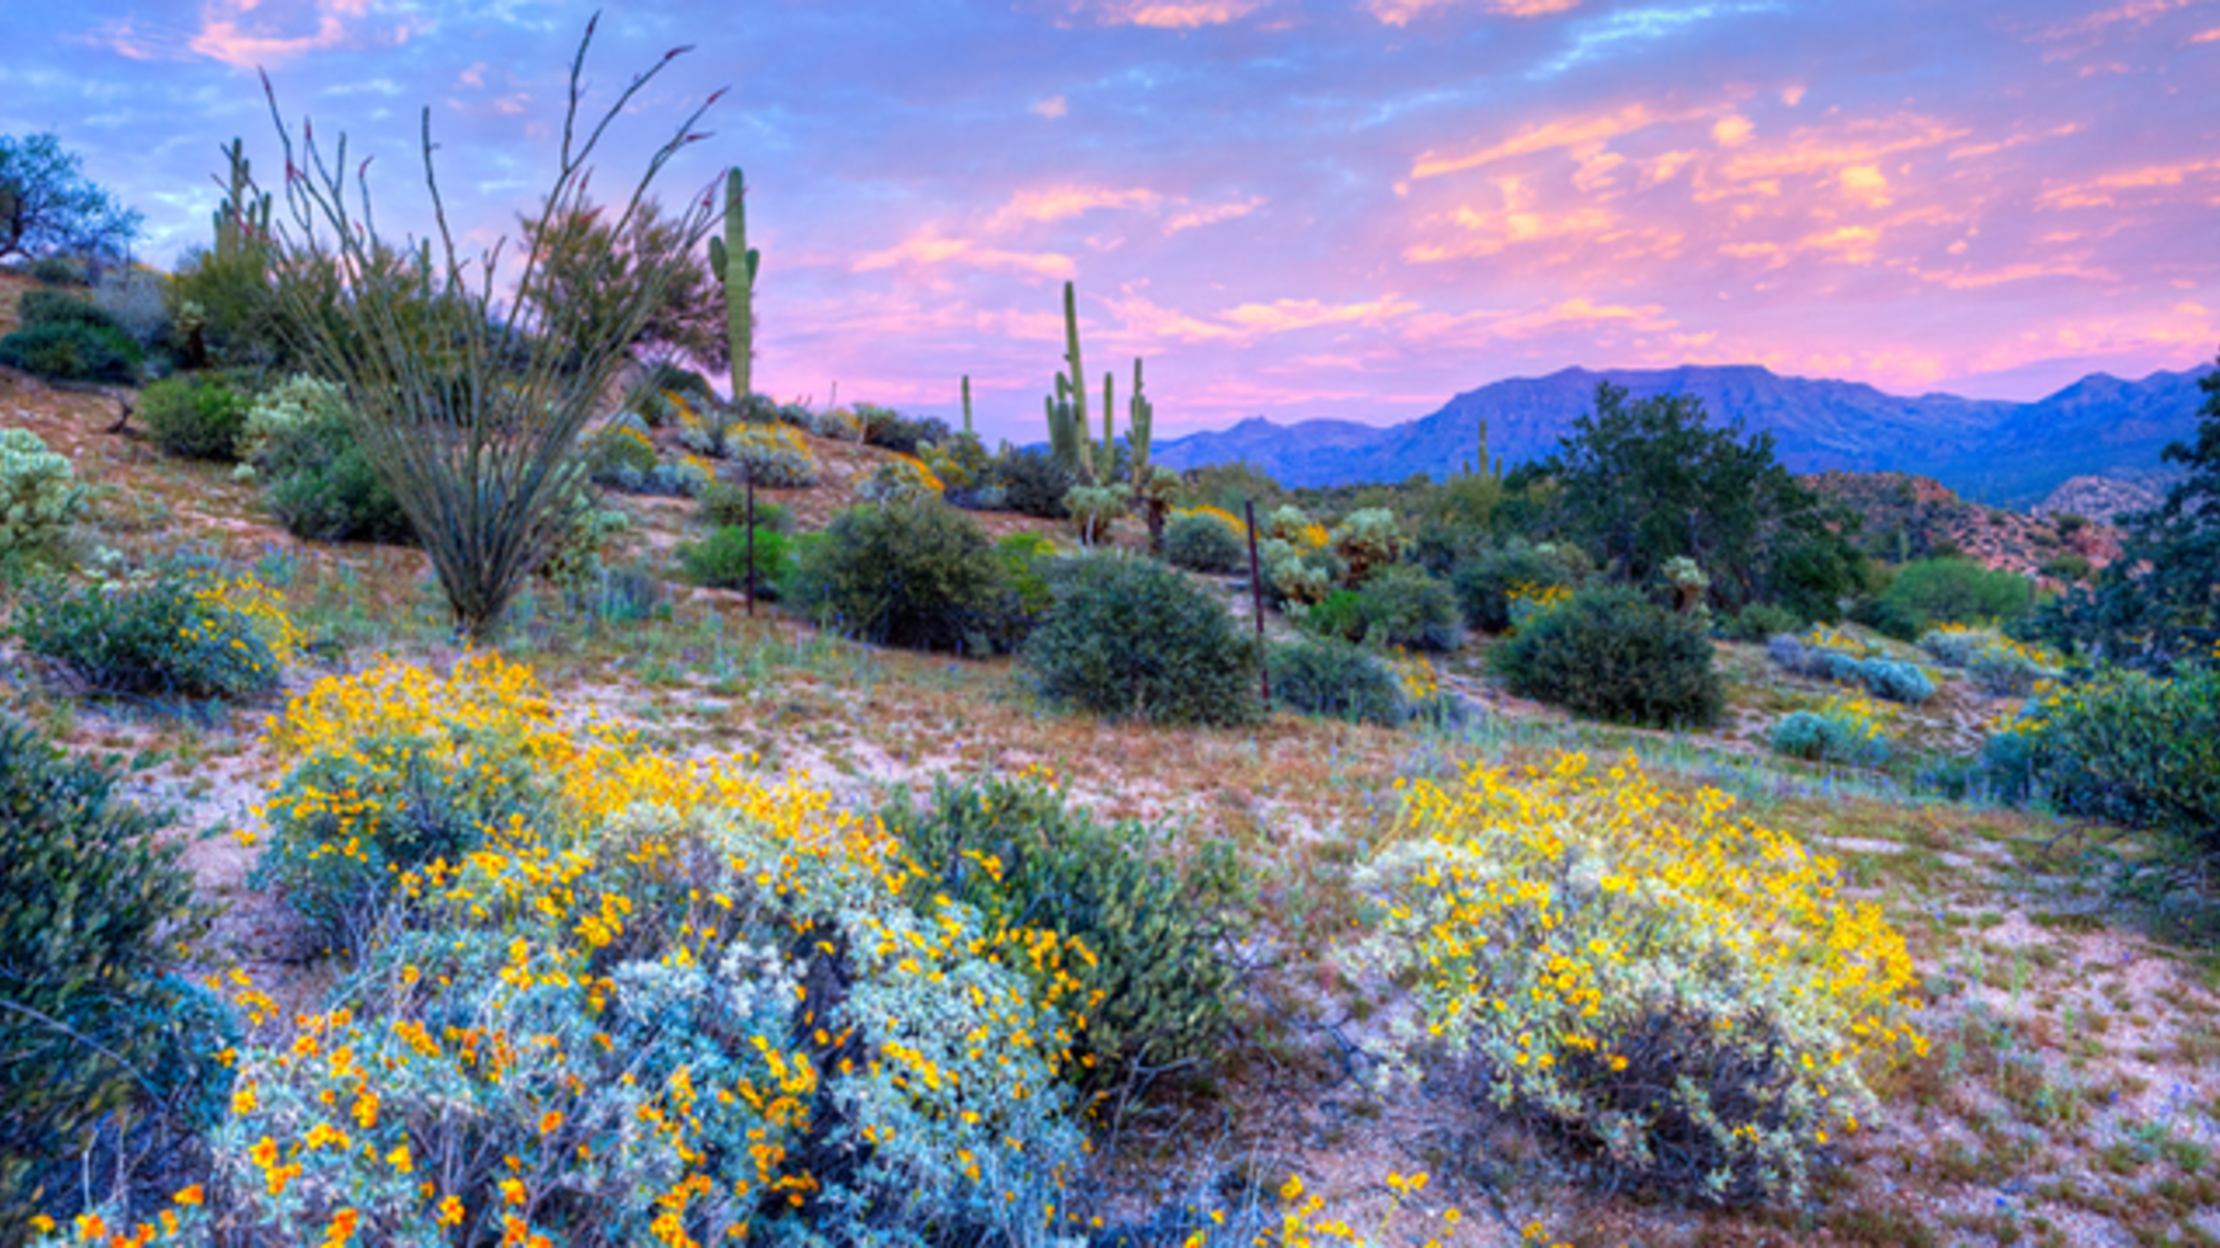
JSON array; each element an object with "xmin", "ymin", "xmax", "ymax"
[{"xmin": 264, "ymin": 22, "xmax": 722, "ymax": 642}]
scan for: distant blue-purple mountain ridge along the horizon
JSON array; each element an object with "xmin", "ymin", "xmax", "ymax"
[{"xmin": 1152, "ymin": 364, "xmax": 2211, "ymax": 506}]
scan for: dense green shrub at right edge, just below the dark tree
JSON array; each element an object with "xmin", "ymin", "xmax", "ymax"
[{"xmin": 1985, "ymin": 668, "xmax": 2220, "ymax": 873}]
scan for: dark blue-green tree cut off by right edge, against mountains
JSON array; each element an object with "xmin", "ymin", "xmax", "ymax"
[{"xmin": 2025, "ymin": 350, "xmax": 2220, "ymax": 673}]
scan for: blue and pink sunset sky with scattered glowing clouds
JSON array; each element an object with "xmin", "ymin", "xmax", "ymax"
[{"xmin": 0, "ymin": 0, "xmax": 2220, "ymax": 440}]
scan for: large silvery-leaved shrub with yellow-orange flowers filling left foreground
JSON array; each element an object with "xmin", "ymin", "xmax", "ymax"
[{"xmin": 129, "ymin": 657, "xmax": 1097, "ymax": 1246}]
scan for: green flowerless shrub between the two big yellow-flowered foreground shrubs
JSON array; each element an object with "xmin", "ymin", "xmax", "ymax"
[{"xmin": 881, "ymin": 775, "xmax": 1243, "ymax": 1095}]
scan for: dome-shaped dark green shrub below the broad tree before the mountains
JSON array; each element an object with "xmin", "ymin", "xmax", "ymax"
[{"xmin": 1490, "ymin": 586, "xmax": 1725, "ymax": 726}]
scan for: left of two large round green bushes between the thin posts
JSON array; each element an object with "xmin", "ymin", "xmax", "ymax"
[{"xmin": 790, "ymin": 500, "xmax": 1008, "ymax": 655}]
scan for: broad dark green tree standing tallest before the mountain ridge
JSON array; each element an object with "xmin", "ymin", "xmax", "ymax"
[{"xmin": 1543, "ymin": 382, "xmax": 1860, "ymax": 620}]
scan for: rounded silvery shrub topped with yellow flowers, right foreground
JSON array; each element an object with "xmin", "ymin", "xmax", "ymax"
[{"xmin": 1359, "ymin": 753, "xmax": 1925, "ymax": 1201}]
